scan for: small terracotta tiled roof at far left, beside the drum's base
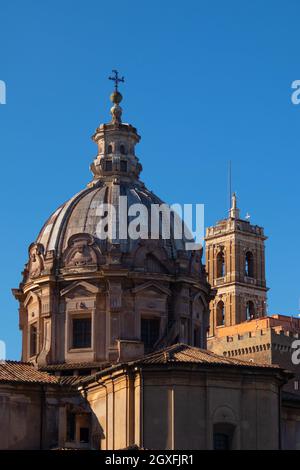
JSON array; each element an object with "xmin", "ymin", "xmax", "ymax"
[{"xmin": 0, "ymin": 361, "xmax": 59, "ymax": 384}]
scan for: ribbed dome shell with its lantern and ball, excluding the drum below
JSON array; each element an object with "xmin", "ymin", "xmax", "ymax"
[{"xmin": 36, "ymin": 85, "xmax": 190, "ymax": 267}]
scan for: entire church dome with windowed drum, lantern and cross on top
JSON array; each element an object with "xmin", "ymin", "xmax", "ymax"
[{"xmin": 13, "ymin": 72, "xmax": 211, "ymax": 368}]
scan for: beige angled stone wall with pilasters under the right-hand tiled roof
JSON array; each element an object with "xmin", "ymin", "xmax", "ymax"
[{"xmin": 86, "ymin": 367, "xmax": 279, "ymax": 450}]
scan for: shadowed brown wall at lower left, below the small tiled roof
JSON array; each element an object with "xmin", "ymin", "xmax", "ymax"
[{"xmin": 0, "ymin": 383, "xmax": 82, "ymax": 450}]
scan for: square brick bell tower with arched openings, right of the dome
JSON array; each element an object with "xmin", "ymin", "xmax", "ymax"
[{"xmin": 205, "ymin": 193, "xmax": 268, "ymax": 336}]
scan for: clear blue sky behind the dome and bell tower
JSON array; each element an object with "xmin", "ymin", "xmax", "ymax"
[{"xmin": 0, "ymin": 0, "xmax": 300, "ymax": 358}]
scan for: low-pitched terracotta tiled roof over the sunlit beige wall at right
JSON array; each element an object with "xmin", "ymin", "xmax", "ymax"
[{"xmin": 134, "ymin": 343, "xmax": 280, "ymax": 369}]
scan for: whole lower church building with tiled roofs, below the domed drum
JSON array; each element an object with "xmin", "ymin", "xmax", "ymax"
[{"xmin": 0, "ymin": 344, "xmax": 288, "ymax": 450}]
